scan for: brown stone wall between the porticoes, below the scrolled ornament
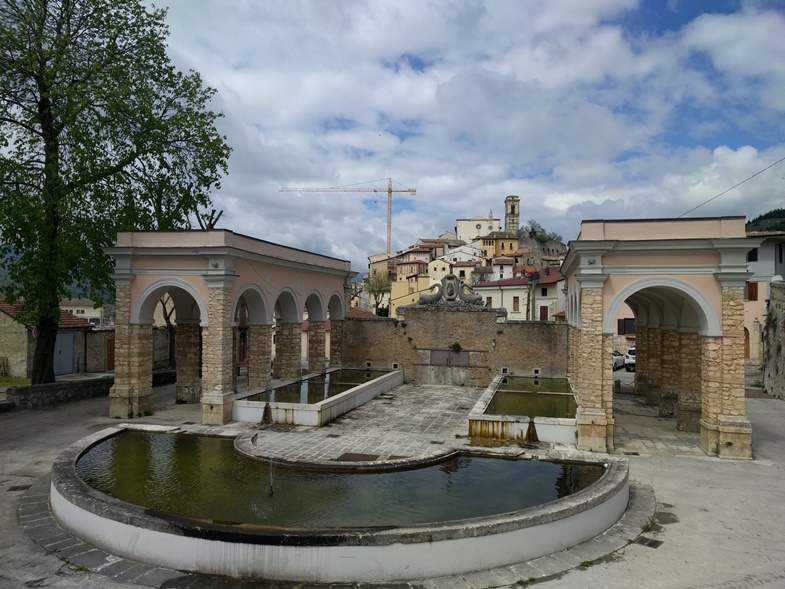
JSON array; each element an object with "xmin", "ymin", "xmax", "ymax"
[{"xmin": 343, "ymin": 308, "xmax": 568, "ymax": 386}]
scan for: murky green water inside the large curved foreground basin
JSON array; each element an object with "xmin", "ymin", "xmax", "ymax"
[{"xmin": 76, "ymin": 430, "xmax": 603, "ymax": 528}]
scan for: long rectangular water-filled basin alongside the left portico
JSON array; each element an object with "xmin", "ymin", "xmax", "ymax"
[{"xmin": 232, "ymin": 368, "xmax": 403, "ymax": 426}]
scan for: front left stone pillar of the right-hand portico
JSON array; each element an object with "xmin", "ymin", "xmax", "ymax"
[{"xmin": 575, "ymin": 288, "xmax": 612, "ymax": 452}]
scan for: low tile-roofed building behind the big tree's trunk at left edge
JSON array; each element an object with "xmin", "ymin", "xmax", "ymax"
[{"xmin": 0, "ymin": 302, "xmax": 93, "ymax": 378}]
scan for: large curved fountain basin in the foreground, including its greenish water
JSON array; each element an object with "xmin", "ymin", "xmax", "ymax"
[{"xmin": 51, "ymin": 428, "xmax": 629, "ymax": 582}]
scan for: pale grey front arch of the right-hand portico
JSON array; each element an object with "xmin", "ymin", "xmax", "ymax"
[{"xmin": 602, "ymin": 276, "xmax": 722, "ymax": 336}]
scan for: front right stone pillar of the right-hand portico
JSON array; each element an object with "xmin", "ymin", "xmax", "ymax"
[{"xmin": 717, "ymin": 286, "xmax": 752, "ymax": 459}]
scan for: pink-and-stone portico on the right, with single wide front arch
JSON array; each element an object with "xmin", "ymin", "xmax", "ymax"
[{"xmin": 562, "ymin": 217, "xmax": 760, "ymax": 458}]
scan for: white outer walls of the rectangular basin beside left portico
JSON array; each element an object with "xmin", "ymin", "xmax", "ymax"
[{"xmin": 232, "ymin": 370, "xmax": 403, "ymax": 427}]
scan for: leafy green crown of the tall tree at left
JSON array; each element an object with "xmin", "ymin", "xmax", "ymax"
[{"xmin": 0, "ymin": 0, "xmax": 230, "ymax": 380}]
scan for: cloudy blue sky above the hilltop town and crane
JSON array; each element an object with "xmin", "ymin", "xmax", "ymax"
[{"xmin": 156, "ymin": 0, "xmax": 785, "ymax": 274}]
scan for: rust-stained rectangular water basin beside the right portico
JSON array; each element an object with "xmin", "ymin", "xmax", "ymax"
[{"xmin": 469, "ymin": 375, "xmax": 577, "ymax": 446}]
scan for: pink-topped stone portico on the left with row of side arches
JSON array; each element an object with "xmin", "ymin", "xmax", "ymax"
[{"xmin": 106, "ymin": 230, "xmax": 354, "ymax": 424}]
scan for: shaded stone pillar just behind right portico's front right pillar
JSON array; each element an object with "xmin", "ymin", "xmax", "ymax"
[{"xmin": 676, "ymin": 331, "xmax": 703, "ymax": 432}]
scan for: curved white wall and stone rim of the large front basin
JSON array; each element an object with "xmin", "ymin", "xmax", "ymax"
[{"xmin": 50, "ymin": 426, "xmax": 629, "ymax": 583}]
